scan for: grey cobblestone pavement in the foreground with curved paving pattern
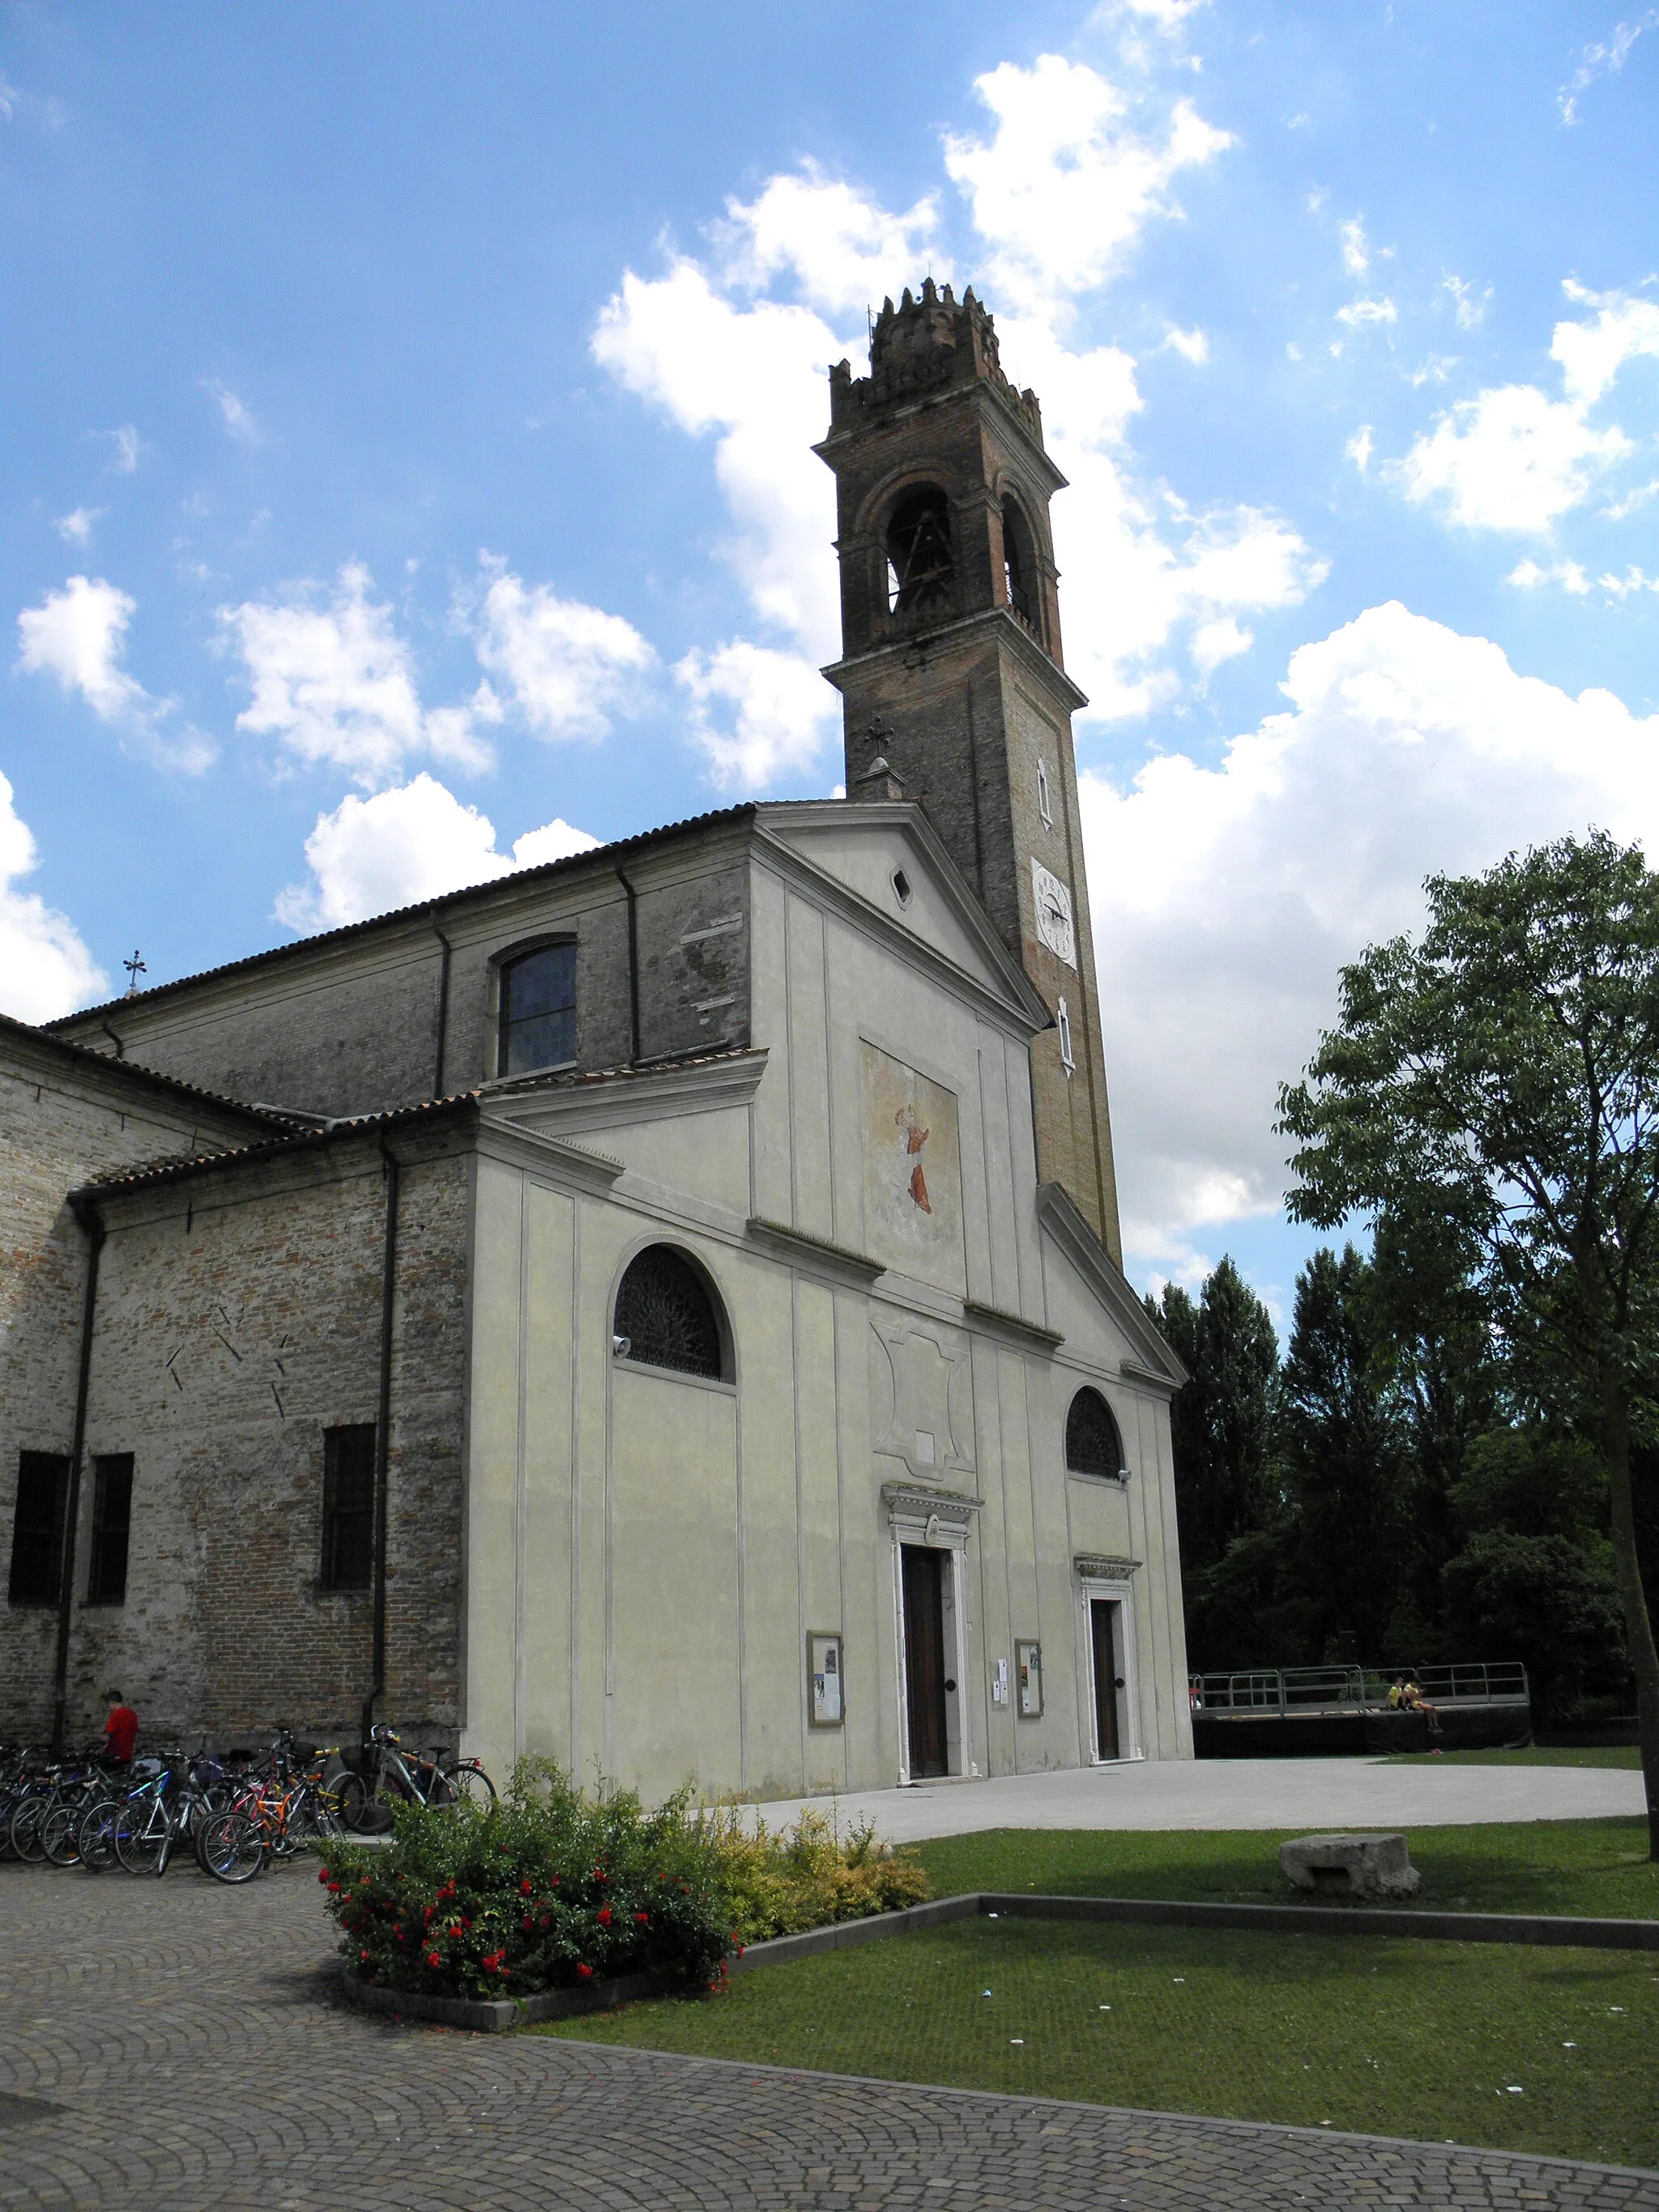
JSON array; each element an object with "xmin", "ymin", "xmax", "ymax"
[{"xmin": 0, "ymin": 1865, "xmax": 1659, "ymax": 2212}]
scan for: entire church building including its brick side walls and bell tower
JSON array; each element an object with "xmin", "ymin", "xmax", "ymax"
[{"xmin": 0, "ymin": 285, "xmax": 1190, "ymax": 1798}]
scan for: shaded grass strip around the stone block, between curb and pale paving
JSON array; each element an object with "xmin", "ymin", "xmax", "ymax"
[{"xmin": 915, "ymin": 1821, "xmax": 1659, "ymax": 1929}]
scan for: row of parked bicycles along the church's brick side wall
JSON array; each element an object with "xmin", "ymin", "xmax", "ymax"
[{"xmin": 0, "ymin": 1725, "xmax": 496, "ymax": 1882}]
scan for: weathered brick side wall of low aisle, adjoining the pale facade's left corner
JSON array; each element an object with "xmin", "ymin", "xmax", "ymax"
[{"xmin": 6, "ymin": 1126, "xmax": 471, "ymax": 1743}]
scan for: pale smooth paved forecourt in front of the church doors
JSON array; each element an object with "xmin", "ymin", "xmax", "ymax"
[{"xmin": 757, "ymin": 1758, "xmax": 1644, "ymax": 1843}]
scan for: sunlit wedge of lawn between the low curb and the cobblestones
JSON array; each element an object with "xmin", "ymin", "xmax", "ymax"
[{"xmin": 542, "ymin": 1911, "xmax": 1659, "ymax": 2166}]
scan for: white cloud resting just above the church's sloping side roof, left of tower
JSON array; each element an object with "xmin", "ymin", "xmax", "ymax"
[{"xmin": 276, "ymin": 769, "xmax": 599, "ymax": 931}]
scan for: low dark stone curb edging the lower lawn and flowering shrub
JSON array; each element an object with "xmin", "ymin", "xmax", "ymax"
[{"xmin": 341, "ymin": 1889, "xmax": 1659, "ymax": 2035}]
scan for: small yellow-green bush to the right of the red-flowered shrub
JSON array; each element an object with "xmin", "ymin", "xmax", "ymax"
[{"xmin": 703, "ymin": 1805, "xmax": 929, "ymax": 1942}]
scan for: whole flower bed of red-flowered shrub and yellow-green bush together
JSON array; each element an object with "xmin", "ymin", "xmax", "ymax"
[{"xmin": 318, "ymin": 1758, "xmax": 927, "ymax": 1997}]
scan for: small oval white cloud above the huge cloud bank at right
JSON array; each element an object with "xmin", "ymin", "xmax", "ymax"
[{"xmin": 1398, "ymin": 385, "xmax": 1631, "ymax": 531}]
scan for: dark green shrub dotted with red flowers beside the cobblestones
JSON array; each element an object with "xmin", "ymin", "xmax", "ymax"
[{"xmin": 318, "ymin": 1758, "xmax": 732, "ymax": 1997}]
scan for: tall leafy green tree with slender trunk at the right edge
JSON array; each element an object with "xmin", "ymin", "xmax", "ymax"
[{"xmin": 1278, "ymin": 834, "xmax": 1659, "ymax": 1860}]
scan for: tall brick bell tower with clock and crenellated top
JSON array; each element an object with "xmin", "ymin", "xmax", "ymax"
[{"xmin": 814, "ymin": 279, "xmax": 1124, "ymax": 1265}]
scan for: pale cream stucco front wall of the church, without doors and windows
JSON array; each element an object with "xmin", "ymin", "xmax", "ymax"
[{"xmin": 467, "ymin": 829, "xmax": 1190, "ymax": 1798}]
